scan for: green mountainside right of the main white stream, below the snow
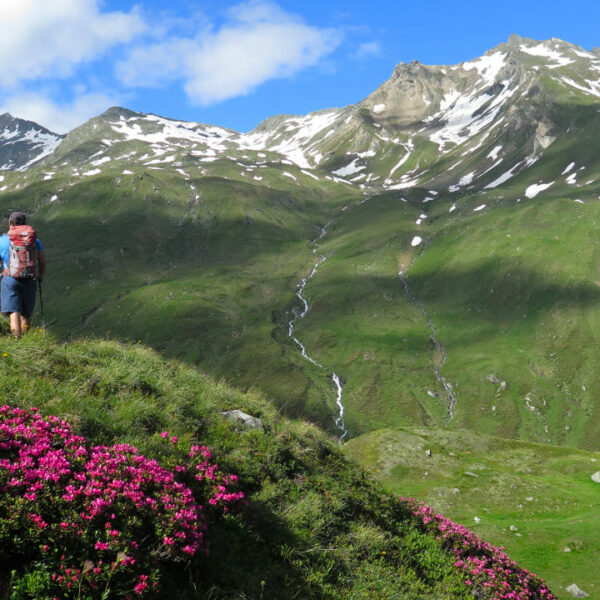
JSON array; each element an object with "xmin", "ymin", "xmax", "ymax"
[{"xmin": 298, "ymin": 171, "xmax": 600, "ymax": 449}]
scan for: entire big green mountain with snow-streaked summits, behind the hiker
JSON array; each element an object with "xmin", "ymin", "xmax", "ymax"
[{"xmin": 0, "ymin": 36, "xmax": 600, "ymax": 448}]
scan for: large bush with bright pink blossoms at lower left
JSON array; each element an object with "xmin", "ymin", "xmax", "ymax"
[{"xmin": 0, "ymin": 406, "xmax": 243, "ymax": 599}]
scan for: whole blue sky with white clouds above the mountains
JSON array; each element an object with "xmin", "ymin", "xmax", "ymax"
[{"xmin": 0, "ymin": 0, "xmax": 600, "ymax": 133}]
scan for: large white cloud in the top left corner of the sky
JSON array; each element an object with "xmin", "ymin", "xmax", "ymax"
[{"xmin": 0, "ymin": 0, "xmax": 145, "ymax": 87}]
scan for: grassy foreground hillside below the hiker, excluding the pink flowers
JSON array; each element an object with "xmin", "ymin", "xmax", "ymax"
[{"xmin": 0, "ymin": 332, "xmax": 471, "ymax": 599}]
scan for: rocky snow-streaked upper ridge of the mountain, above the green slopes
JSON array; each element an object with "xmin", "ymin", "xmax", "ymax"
[{"xmin": 3, "ymin": 34, "xmax": 600, "ymax": 198}]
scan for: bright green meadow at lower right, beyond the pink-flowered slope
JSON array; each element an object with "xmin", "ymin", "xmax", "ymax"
[{"xmin": 346, "ymin": 428, "xmax": 600, "ymax": 599}]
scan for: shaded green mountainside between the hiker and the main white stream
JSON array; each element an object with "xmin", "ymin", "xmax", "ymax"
[{"xmin": 0, "ymin": 167, "xmax": 359, "ymax": 432}]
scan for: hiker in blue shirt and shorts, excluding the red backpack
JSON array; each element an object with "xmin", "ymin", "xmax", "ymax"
[{"xmin": 0, "ymin": 212, "xmax": 46, "ymax": 339}]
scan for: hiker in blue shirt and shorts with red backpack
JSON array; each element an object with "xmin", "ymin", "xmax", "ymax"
[{"xmin": 0, "ymin": 212, "xmax": 46, "ymax": 339}]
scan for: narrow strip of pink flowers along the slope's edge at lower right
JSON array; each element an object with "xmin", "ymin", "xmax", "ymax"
[{"xmin": 399, "ymin": 498, "xmax": 556, "ymax": 600}]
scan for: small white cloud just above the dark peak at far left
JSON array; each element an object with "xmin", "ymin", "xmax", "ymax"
[{"xmin": 0, "ymin": 92, "xmax": 121, "ymax": 133}]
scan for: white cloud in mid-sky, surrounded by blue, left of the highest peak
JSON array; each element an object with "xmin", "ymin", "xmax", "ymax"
[{"xmin": 117, "ymin": 1, "xmax": 342, "ymax": 104}]
